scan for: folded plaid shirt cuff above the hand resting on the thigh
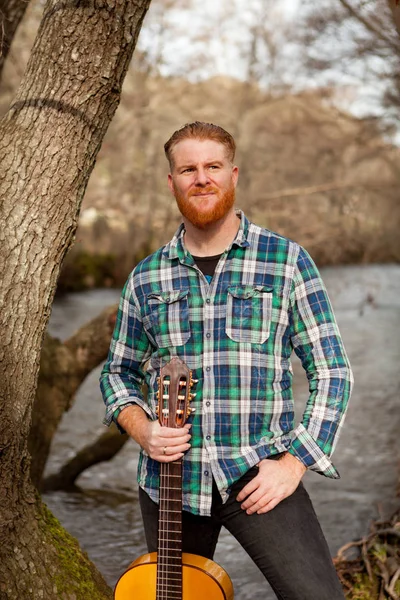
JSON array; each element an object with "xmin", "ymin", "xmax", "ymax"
[{"xmin": 288, "ymin": 423, "xmax": 340, "ymax": 479}]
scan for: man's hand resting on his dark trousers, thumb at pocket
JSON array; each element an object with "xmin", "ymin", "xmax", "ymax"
[{"xmin": 236, "ymin": 453, "xmax": 307, "ymax": 515}]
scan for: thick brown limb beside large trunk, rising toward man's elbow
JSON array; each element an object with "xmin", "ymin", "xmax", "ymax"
[{"xmin": 28, "ymin": 306, "xmax": 117, "ymax": 491}]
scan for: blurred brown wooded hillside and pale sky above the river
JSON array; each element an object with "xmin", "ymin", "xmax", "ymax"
[{"xmin": 0, "ymin": 0, "xmax": 400, "ymax": 291}]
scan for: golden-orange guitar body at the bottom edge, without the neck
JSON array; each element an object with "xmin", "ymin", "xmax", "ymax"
[{"xmin": 114, "ymin": 552, "xmax": 233, "ymax": 600}]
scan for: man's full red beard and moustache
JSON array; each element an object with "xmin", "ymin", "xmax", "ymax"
[{"xmin": 174, "ymin": 183, "xmax": 235, "ymax": 229}]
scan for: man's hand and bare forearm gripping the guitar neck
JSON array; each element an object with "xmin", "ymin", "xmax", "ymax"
[{"xmin": 118, "ymin": 406, "xmax": 191, "ymax": 462}]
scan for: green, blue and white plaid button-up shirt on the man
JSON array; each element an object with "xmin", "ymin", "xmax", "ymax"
[{"xmin": 101, "ymin": 213, "xmax": 352, "ymax": 515}]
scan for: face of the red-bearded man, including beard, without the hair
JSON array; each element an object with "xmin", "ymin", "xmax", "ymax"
[{"xmin": 168, "ymin": 139, "xmax": 238, "ymax": 229}]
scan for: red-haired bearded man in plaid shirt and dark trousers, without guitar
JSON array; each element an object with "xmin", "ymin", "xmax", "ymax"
[{"xmin": 101, "ymin": 122, "xmax": 352, "ymax": 600}]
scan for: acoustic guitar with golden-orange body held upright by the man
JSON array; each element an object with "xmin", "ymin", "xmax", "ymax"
[{"xmin": 114, "ymin": 358, "xmax": 233, "ymax": 600}]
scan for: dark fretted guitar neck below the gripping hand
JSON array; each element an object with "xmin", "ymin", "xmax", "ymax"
[{"xmin": 156, "ymin": 459, "xmax": 182, "ymax": 600}]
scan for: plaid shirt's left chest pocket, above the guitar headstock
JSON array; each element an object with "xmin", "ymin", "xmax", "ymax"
[{"xmin": 146, "ymin": 290, "xmax": 190, "ymax": 348}]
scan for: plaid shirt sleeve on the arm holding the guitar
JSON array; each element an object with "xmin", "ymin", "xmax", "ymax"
[{"xmin": 100, "ymin": 275, "xmax": 156, "ymax": 431}]
